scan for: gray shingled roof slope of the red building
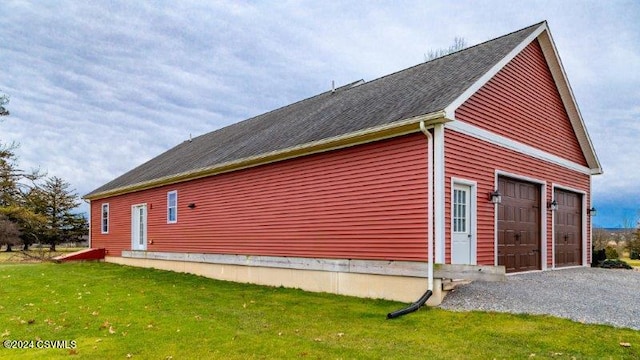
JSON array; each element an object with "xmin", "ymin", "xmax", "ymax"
[{"xmin": 86, "ymin": 24, "xmax": 540, "ymax": 196}]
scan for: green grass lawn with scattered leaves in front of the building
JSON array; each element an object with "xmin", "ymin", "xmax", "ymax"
[{"xmin": 0, "ymin": 263, "xmax": 640, "ymax": 359}]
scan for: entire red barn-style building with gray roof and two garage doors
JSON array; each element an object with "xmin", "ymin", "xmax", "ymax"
[{"xmin": 85, "ymin": 22, "xmax": 602, "ymax": 304}]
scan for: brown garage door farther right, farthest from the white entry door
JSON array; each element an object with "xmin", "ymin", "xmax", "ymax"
[{"xmin": 553, "ymin": 189, "xmax": 582, "ymax": 267}]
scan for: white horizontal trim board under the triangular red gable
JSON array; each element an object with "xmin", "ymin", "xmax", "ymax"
[{"xmin": 444, "ymin": 120, "xmax": 593, "ymax": 175}]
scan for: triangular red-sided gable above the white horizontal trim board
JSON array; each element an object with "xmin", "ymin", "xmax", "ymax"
[{"xmin": 456, "ymin": 40, "xmax": 587, "ymax": 166}]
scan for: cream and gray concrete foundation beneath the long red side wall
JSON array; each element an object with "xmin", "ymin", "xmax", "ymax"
[{"xmin": 105, "ymin": 251, "xmax": 505, "ymax": 306}]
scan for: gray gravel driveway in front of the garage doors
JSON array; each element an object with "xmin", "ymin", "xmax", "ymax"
[{"xmin": 440, "ymin": 268, "xmax": 640, "ymax": 330}]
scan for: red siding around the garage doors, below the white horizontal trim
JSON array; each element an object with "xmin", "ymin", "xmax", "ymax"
[{"xmin": 445, "ymin": 129, "xmax": 591, "ymax": 266}]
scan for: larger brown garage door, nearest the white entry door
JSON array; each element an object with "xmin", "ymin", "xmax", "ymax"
[{"xmin": 498, "ymin": 177, "xmax": 540, "ymax": 272}]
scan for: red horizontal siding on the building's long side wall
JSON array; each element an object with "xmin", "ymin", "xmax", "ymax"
[{"xmin": 92, "ymin": 135, "xmax": 427, "ymax": 261}]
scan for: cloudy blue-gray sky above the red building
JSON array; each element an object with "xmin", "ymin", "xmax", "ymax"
[{"xmin": 0, "ymin": 0, "xmax": 640, "ymax": 227}]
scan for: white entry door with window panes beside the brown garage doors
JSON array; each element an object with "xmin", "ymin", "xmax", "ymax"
[{"xmin": 451, "ymin": 184, "xmax": 472, "ymax": 264}]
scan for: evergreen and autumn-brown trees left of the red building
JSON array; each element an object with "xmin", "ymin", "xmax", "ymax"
[{"xmin": 0, "ymin": 94, "xmax": 89, "ymax": 251}]
